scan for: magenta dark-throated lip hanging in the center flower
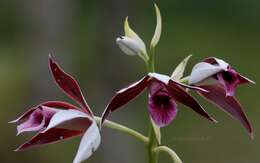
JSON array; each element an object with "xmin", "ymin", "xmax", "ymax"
[{"xmin": 148, "ymin": 82, "xmax": 177, "ymax": 127}]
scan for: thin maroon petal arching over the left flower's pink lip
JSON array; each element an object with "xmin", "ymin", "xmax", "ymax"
[{"xmin": 9, "ymin": 101, "xmax": 78, "ymax": 123}]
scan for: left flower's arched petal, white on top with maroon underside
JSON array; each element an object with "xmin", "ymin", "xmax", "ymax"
[{"xmin": 42, "ymin": 109, "xmax": 93, "ymax": 132}]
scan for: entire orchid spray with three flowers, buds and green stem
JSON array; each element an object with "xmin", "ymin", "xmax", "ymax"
[{"xmin": 10, "ymin": 5, "xmax": 254, "ymax": 163}]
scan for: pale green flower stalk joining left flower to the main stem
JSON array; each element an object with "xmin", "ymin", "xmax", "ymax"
[{"xmin": 95, "ymin": 116, "xmax": 149, "ymax": 144}]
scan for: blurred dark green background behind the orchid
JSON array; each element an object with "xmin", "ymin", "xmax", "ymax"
[{"xmin": 0, "ymin": 0, "xmax": 260, "ymax": 163}]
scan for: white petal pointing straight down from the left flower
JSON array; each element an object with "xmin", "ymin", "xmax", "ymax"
[{"xmin": 73, "ymin": 122, "xmax": 101, "ymax": 163}]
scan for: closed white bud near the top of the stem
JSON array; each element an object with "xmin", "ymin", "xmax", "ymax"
[{"xmin": 116, "ymin": 36, "xmax": 143, "ymax": 55}]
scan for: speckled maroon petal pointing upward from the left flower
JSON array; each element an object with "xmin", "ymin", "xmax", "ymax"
[{"xmin": 49, "ymin": 56, "xmax": 93, "ymax": 116}]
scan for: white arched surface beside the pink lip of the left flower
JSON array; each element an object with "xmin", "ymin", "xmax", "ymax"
[{"xmin": 42, "ymin": 109, "xmax": 92, "ymax": 132}]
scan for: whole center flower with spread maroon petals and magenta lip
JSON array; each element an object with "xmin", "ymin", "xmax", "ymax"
[{"xmin": 102, "ymin": 73, "xmax": 215, "ymax": 127}]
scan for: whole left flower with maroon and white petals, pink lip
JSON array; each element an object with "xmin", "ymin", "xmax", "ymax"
[{"xmin": 10, "ymin": 57, "xmax": 101, "ymax": 163}]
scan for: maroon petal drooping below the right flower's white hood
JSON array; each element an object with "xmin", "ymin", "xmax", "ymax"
[{"xmin": 199, "ymin": 85, "xmax": 253, "ymax": 137}]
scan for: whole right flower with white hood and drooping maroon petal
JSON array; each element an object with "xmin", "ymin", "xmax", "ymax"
[{"xmin": 188, "ymin": 57, "xmax": 254, "ymax": 137}]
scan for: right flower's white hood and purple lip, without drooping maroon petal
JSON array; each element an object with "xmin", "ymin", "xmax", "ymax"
[{"xmin": 189, "ymin": 57, "xmax": 254, "ymax": 96}]
